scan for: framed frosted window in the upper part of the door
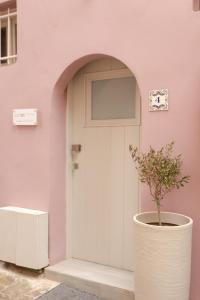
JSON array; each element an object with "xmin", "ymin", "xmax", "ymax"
[{"xmin": 84, "ymin": 69, "xmax": 140, "ymax": 127}]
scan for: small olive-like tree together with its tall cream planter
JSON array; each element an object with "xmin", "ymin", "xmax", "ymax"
[{"xmin": 130, "ymin": 142, "xmax": 193, "ymax": 300}]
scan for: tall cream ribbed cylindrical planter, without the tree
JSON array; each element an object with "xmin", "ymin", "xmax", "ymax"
[{"xmin": 134, "ymin": 212, "xmax": 193, "ymax": 300}]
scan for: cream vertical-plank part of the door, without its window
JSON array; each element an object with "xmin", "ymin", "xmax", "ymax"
[{"xmin": 68, "ymin": 57, "xmax": 139, "ymax": 270}]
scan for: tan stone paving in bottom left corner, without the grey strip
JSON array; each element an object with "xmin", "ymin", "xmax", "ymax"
[{"xmin": 0, "ymin": 263, "xmax": 59, "ymax": 300}]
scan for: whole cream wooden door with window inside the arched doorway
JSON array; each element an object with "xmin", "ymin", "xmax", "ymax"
[{"xmin": 67, "ymin": 61, "xmax": 140, "ymax": 270}]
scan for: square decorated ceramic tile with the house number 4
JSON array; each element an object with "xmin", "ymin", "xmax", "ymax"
[{"xmin": 149, "ymin": 89, "xmax": 168, "ymax": 111}]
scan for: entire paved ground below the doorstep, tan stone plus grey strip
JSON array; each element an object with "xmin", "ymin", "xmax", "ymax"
[{"xmin": 0, "ymin": 262, "xmax": 103, "ymax": 300}]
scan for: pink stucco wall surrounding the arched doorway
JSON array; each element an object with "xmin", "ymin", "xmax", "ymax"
[{"xmin": 0, "ymin": 0, "xmax": 200, "ymax": 300}]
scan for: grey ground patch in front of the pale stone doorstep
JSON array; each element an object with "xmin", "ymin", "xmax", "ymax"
[{"xmin": 38, "ymin": 284, "xmax": 103, "ymax": 300}]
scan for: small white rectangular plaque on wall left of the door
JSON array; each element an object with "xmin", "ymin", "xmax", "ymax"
[{"xmin": 13, "ymin": 108, "xmax": 37, "ymax": 126}]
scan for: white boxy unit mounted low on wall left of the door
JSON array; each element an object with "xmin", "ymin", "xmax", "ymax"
[{"xmin": 0, "ymin": 206, "xmax": 48, "ymax": 270}]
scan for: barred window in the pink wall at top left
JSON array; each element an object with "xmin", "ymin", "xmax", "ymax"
[{"xmin": 0, "ymin": 1, "xmax": 17, "ymax": 65}]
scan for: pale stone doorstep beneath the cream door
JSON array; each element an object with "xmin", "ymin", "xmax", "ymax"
[{"xmin": 45, "ymin": 259, "xmax": 134, "ymax": 300}]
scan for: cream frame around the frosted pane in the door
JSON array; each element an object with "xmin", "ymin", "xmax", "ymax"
[{"xmin": 84, "ymin": 69, "xmax": 140, "ymax": 127}]
